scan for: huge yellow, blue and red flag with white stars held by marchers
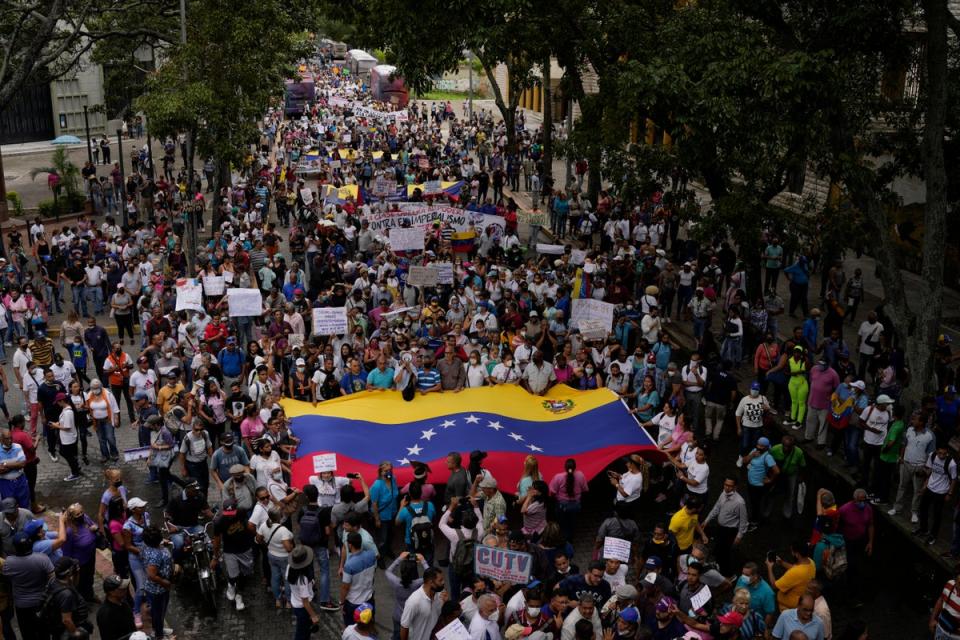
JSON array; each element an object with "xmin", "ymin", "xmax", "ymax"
[{"xmin": 282, "ymin": 385, "xmax": 656, "ymax": 493}]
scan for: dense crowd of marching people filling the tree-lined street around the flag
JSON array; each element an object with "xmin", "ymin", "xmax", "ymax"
[{"xmin": 0, "ymin": 53, "xmax": 960, "ymax": 640}]
